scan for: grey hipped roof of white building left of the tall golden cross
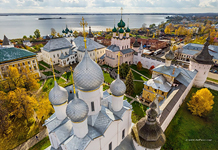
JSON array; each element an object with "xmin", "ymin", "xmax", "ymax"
[{"xmin": 43, "ymin": 38, "xmax": 72, "ymax": 52}]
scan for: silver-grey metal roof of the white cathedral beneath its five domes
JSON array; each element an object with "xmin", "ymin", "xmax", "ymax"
[{"xmin": 45, "ymin": 91, "xmax": 132, "ymax": 150}]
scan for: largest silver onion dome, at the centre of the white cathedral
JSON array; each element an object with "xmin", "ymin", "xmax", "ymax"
[{"xmin": 73, "ymin": 50, "xmax": 104, "ymax": 91}]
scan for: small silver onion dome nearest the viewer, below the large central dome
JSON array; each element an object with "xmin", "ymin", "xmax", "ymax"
[{"xmin": 66, "ymin": 97, "xmax": 89, "ymax": 123}]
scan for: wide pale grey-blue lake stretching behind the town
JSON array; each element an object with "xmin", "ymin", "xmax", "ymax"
[{"xmin": 0, "ymin": 14, "xmax": 167, "ymax": 39}]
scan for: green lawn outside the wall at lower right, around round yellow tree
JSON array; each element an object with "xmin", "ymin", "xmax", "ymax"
[{"xmin": 162, "ymin": 88, "xmax": 218, "ymax": 150}]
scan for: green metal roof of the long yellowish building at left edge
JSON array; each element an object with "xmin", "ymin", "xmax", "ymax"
[{"xmin": 0, "ymin": 47, "xmax": 36, "ymax": 63}]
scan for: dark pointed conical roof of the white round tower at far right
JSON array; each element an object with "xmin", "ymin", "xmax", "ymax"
[{"xmin": 191, "ymin": 35, "xmax": 214, "ymax": 64}]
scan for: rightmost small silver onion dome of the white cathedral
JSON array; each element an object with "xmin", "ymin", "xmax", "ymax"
[{"xmin": 110, "ymin": 74, "xmax": 126, "ymax": 96}]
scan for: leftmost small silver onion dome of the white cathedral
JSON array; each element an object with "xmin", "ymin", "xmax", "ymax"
[{"xmin": 49, "ymin": 81, "xmax": 68, "ymax": 105}]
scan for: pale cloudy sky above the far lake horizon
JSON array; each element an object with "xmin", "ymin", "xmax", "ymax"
[{"xmin": 0, "ymin": 0, "xmax": 218, "ymax": 13}]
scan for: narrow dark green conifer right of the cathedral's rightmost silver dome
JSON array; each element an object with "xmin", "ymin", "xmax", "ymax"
[{"xmin": 125, "ymin": 69, "xmax": 134, "ymax": 95}]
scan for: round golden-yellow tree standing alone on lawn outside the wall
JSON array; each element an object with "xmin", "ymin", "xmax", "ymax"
[{"xmin": 187, "ymin": 88, "xmax": 214, "ymax": 117}]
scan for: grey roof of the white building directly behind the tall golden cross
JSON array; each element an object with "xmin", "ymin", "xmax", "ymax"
[{"xmin": 73, "ymin": 36, "xmax": 105, "ymax": 52}]
